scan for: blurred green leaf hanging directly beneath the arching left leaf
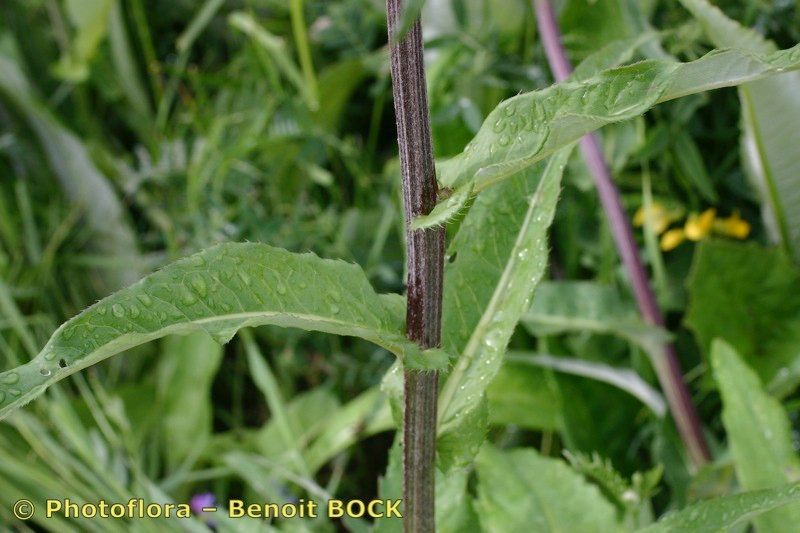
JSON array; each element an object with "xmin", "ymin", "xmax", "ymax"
[{"xmin": 156, "ymin": 332, "xmax": 222, "ymax": 468}]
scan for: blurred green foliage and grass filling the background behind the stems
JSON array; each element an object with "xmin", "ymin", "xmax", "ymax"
[{"xmin": 0, "ymin": 0, "xmax": 800, "ymax": 531}]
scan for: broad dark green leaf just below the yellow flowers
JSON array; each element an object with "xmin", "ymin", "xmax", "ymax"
[{"xmin": 685, "ymin": 241, "xmax": 800, "ymax": 394}]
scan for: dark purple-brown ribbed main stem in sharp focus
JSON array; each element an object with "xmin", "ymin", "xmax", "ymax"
[{"xmin": 386, "ymin": 0, "xmax": 444, "ymax": 532}]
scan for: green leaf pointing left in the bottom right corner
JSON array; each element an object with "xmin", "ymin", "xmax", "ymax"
[{"xmin": 639, "ymin": 483, "xmax": 800, "ymax": 533}]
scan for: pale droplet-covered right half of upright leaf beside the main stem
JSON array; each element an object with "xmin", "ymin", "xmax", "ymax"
[{"xmin": 438, "ymin": 147, "xmax": 572, "ymax": 469}]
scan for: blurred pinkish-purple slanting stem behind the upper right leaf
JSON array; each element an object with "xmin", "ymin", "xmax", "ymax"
[{"xmin": 534, "ymin": 0, "xmax": 710, "ymax": 466}]
